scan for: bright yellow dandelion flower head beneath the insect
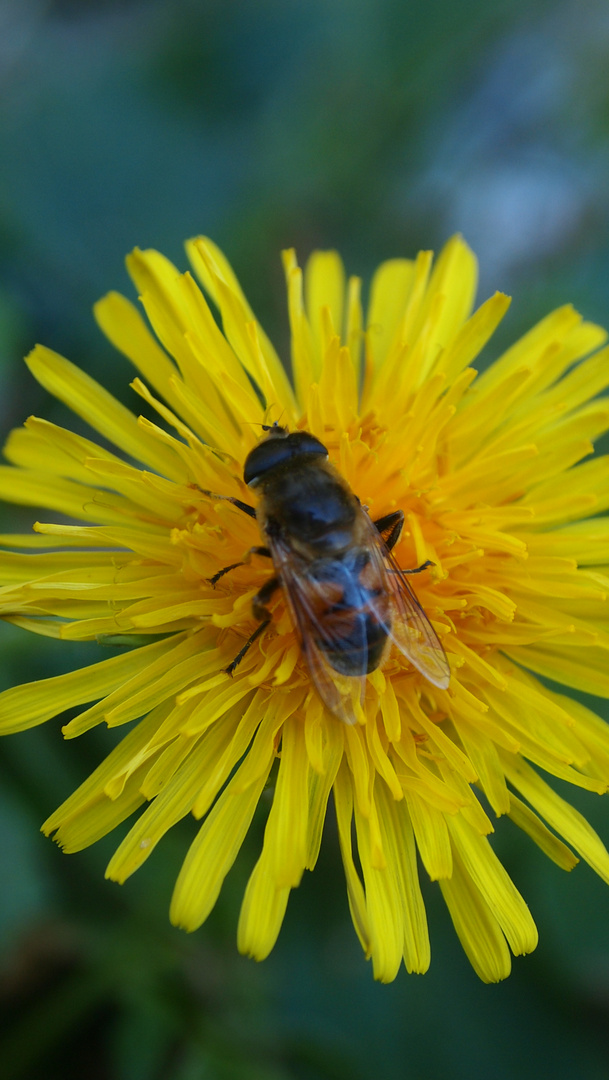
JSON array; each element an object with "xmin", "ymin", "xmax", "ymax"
[{"xmin": 0, "ymin": 238, "xmax": 609, "ymax": 982}]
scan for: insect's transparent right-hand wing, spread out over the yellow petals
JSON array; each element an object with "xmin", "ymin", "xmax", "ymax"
[{"xmin": 362, "ymin": 509, "xmax": 450, "ymax": 690}]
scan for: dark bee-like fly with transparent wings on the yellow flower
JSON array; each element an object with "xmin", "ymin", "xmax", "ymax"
[{"xmin": 207, "ymin": 423, "xmax": 450, "ymax": 724}]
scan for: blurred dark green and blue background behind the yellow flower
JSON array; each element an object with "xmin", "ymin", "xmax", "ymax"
[{"xmin": 0, "ymin": 0, "xmax": 609, "ymax": 1080}]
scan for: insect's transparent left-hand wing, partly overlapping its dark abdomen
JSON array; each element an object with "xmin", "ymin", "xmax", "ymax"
[{"xmin": 269, "ymin": 538, "xmax": 367, "ymax": 724}]
